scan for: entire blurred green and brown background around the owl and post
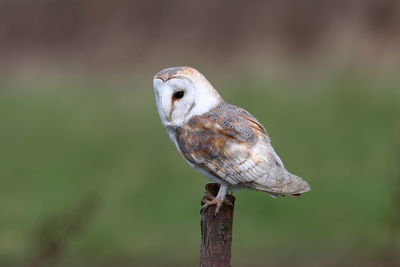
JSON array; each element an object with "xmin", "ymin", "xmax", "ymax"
[{"xmin": 0, "ymin": 0, "xmax": 400, "ymax": 266}]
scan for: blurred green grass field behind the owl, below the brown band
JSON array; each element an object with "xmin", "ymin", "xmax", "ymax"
[{"xmin": 0, "ymin": 70, "xmax": 400, "ymax": 266}]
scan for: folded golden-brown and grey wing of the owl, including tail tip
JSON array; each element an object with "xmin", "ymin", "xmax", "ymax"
[{"xmin": 180, "ymin": 105, "xmax": 309, "ymax": 195}]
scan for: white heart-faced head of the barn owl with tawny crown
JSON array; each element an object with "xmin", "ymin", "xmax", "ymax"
[{"xmin": 154, "ymin": 67, "xmax": 223, "ymax": 127}]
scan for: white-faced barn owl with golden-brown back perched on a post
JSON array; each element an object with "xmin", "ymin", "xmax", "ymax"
[{"xmin": 154, "ymin": 67, "xmax": 311, "ymax": 213}]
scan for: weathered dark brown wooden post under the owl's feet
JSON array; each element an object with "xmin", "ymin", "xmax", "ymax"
[{"xmin": 200, "ymin": 183, "xmax": 235, "ymax": 267}]
